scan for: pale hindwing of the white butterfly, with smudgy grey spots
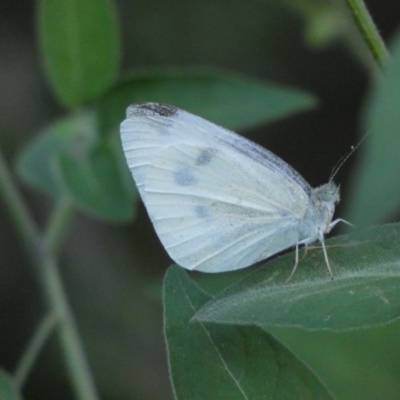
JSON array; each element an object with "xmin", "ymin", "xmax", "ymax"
[{"xmin": 143, "ymin": 142, "xmax": 307, "ymax": 272}]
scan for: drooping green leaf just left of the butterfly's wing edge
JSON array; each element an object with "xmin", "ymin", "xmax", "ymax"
[{"xmin": 61, "ymin": 136, "xmax": 136, "ymax": 222}]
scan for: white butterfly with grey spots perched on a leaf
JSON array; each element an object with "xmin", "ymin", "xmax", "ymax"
[{"xmin": 121, "ymin": 103, "xmax": 346, "ymax": 276}]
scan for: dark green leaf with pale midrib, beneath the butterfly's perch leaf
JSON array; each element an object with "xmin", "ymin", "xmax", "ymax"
[{"xmin": 164, "ymin": 266, "xmax": 333, "ymax": 400}]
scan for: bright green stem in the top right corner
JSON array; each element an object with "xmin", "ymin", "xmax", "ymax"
[{"xmin": 346, "ymin": 0, "xmax": 389, "ymax": 68}]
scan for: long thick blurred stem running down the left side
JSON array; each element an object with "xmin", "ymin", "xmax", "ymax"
[{"xmin": 0, "ymin": 151, "xmax": 98, "ymax": 400}]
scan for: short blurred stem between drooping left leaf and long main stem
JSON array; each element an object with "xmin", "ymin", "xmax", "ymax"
[{"xmin": 45, "ymin": 195, "xmax": 74, "ymax": 254}]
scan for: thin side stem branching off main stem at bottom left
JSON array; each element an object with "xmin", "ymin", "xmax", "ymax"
[{"xmin": 14, "ymin": 313, "xmax": 57, "ymax": 390}]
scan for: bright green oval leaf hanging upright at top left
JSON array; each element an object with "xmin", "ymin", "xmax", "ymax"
[{"xmin": 38, "ymin": 0, "xmax": 120, "ymax": 108}]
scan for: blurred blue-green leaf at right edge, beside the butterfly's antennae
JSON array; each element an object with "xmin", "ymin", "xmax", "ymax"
[{"xmin": 347, "ymin": 31, "xmax": 400, "ymax": 227}]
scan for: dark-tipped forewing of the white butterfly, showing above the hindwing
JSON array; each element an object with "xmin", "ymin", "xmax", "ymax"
[{"xmin": 121, "ymin": 103, "xmax": 312, "ymax": 195}]
